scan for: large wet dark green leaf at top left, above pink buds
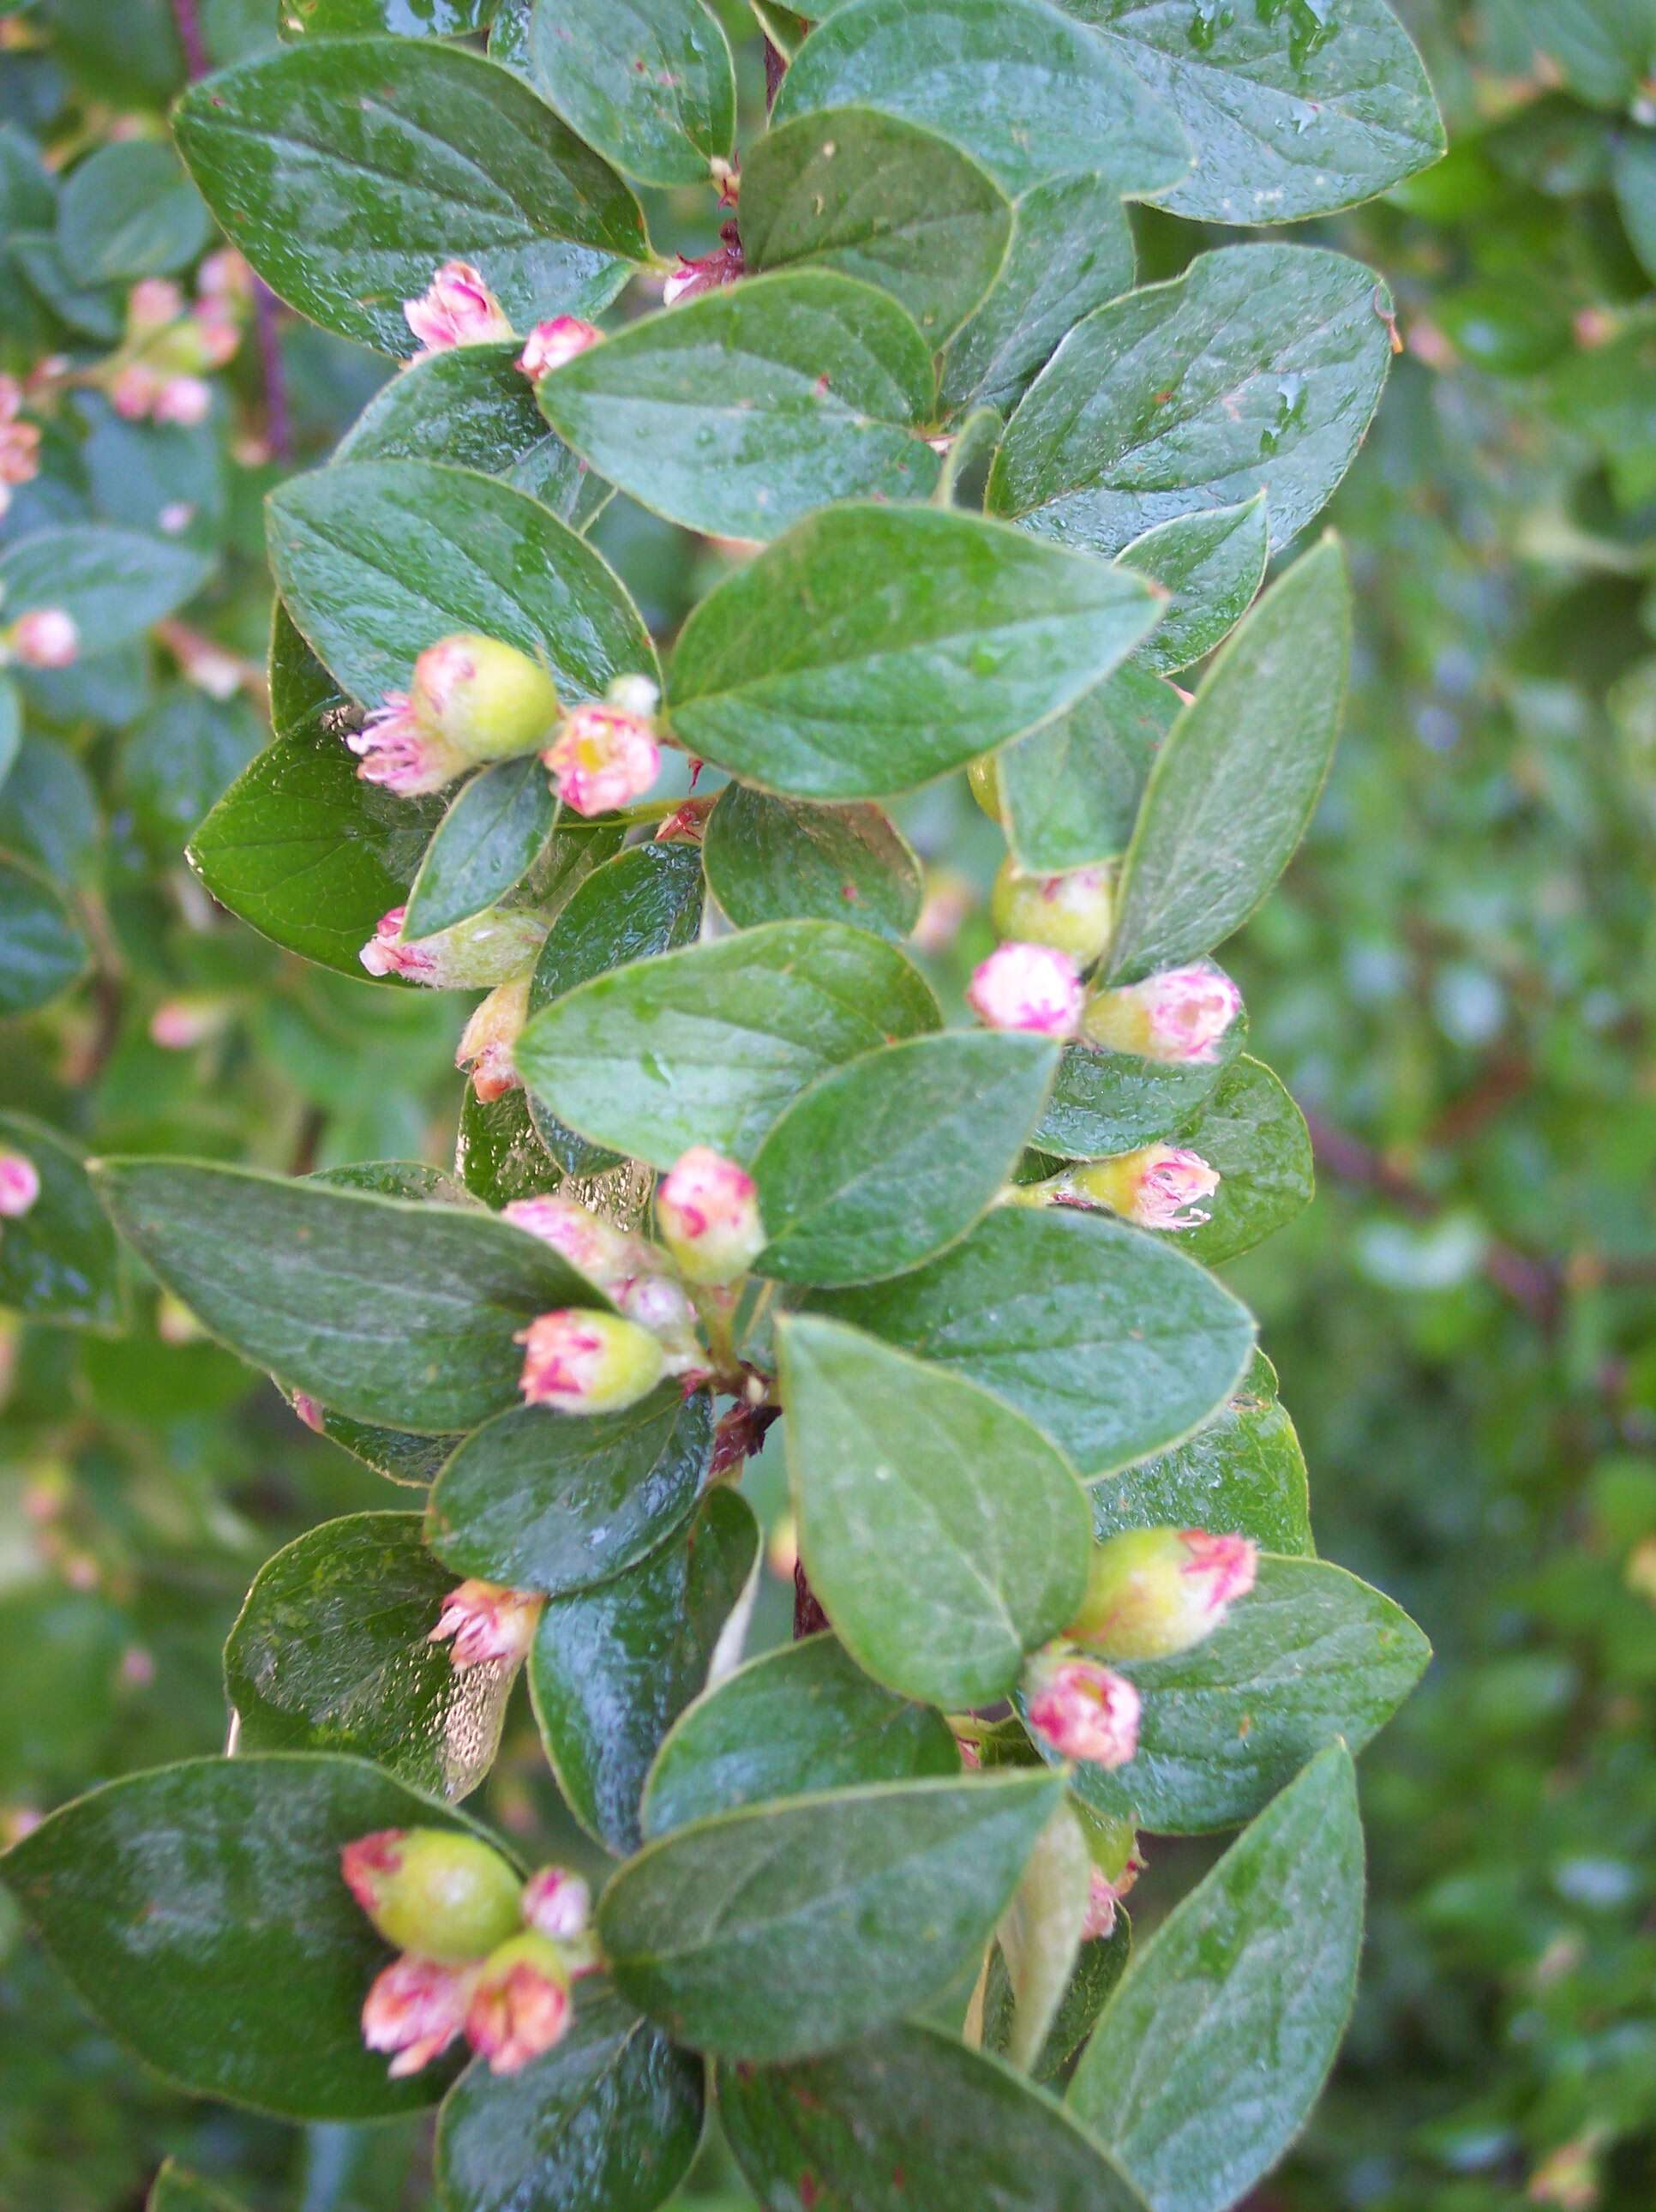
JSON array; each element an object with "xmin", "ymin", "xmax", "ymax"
[{"xmin": 172, "ymin": 38, "xmax": 650, "ymax": 356}]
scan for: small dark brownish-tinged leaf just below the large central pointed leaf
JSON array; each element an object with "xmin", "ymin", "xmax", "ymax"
[{"xmin": 701, "ymin": 783, "xmax": 924, "ymax": 941}]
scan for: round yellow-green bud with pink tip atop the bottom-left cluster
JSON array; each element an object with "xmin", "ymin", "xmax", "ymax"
[{"xmin": 339, "ymin": 1827, "xmax": 522, "ymax": 1967}]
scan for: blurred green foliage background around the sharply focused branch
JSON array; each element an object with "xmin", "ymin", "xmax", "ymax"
[{"xmin": 0, "ymin": 0, "xmax": 1656, "ymax": 2212}]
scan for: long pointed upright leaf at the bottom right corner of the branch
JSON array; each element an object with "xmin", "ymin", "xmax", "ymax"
[{"xmin": 1070, "ymin": 1746, "xmax": 1362, "ymax": 2212}]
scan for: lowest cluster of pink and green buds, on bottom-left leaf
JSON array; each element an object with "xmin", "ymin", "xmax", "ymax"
[{"xmin": 340, "ymin": 1827, "xmax": 599, "ymax": 2077}]
